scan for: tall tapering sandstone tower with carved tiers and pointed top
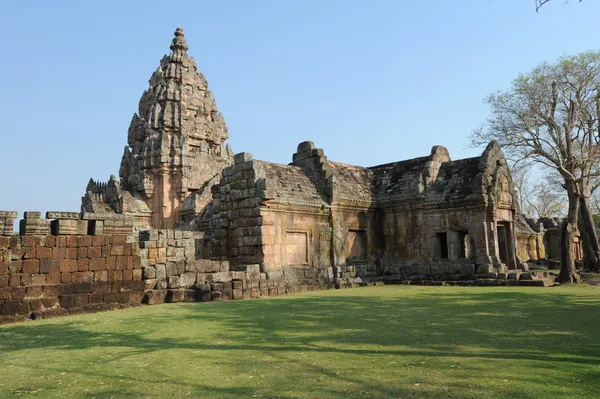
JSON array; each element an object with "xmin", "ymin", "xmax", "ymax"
[{"xmin": 82, "ymin": 28, "xmax": 233, "ymax": 228}]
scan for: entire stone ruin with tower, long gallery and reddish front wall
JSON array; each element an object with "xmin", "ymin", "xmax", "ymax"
[{"xmin": 0, "ymin": 29, "xmax": 553, "ymax": 322}]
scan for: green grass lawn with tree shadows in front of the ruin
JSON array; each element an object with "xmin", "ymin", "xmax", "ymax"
[{"xmin": 0, "ymin": 285, "xmax": 600, "ymax": 399}]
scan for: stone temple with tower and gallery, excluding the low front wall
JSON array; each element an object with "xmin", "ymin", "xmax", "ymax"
[{"xmin": 82, "ymin": 29, "xmax": 518, "ymax": 276}]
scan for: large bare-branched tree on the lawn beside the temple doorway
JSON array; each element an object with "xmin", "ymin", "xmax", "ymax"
[{"xmin": 471, "ymin": 51, "xmax": 600, "ymax": 282}]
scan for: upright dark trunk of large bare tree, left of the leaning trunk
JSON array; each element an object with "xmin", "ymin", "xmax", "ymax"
[{"xmin": 558, "ymin": 191, "xmax": 581, "ymax": 284}]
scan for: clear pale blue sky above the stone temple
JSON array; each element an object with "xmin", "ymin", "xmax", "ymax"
[{"xmin": 0, "ymin": 0, "xmax": 600, "ymax": 219}]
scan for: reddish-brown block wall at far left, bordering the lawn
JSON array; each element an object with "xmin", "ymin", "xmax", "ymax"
[{"xmin": 0, "ymin": 230, "xmax": 145, "ymax": 323}]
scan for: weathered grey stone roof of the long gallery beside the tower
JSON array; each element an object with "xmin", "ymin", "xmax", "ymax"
[{"xmin": 248, "ymin": 142, "xmax": 503, "ymax": 211}]
